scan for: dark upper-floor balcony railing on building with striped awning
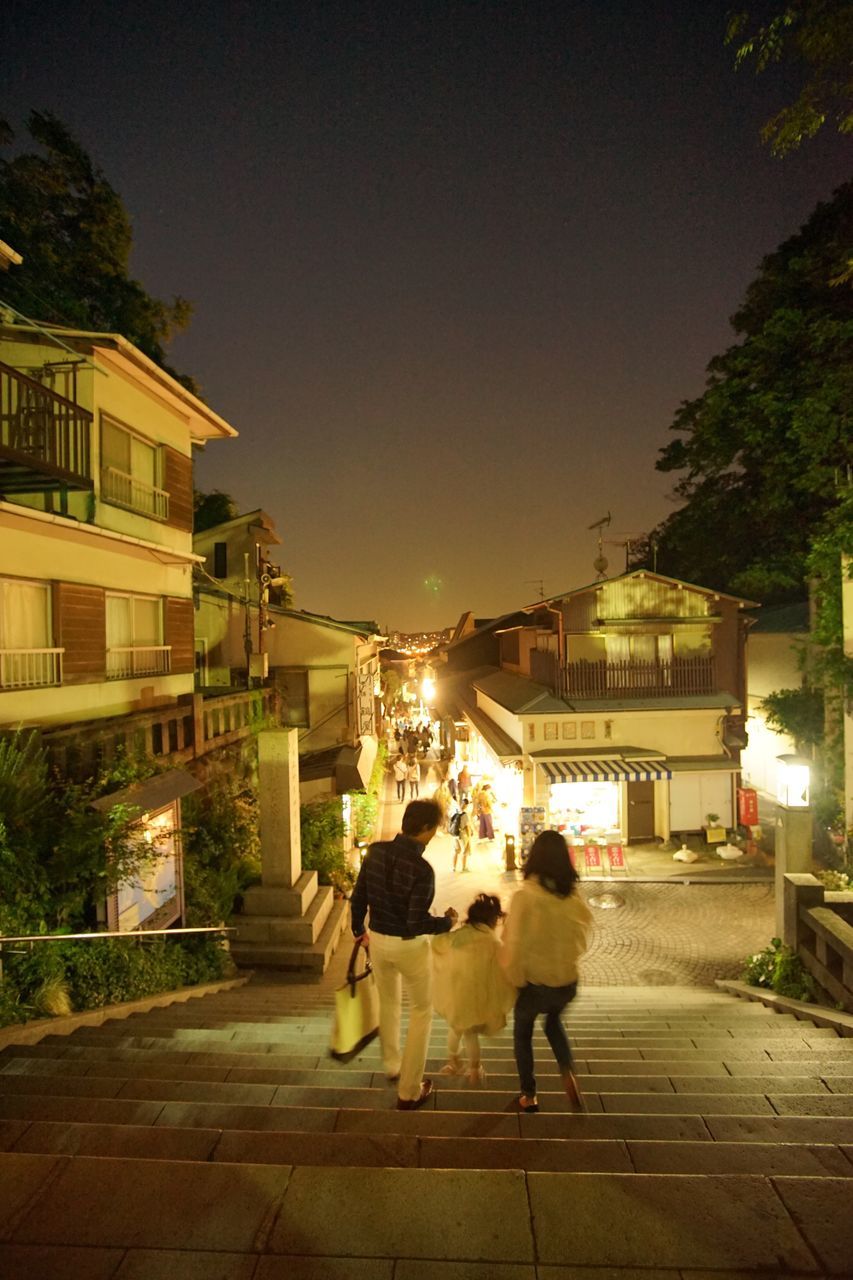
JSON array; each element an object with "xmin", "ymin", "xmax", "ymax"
[{"xmin": 561, "ymin": 655, "xmax": 715, "ymax": 698}]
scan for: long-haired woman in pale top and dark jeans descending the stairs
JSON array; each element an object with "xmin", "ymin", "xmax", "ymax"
[{"xmin": 505, "ymin": 831, "xmax": 592, "ymax": 1112}]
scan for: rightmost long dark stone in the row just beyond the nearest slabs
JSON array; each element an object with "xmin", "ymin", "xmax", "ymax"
[{"xmin": 628, "ymin": 1142, "xmax": 853, "ymax": 1177}]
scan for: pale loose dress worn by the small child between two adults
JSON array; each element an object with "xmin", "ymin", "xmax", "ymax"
[{"xmin": 433, "ymin": 924, "xmax": 516, "ymax": 1036}]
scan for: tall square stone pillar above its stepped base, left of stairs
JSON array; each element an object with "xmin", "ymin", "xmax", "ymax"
[{"xmin": 257, "ymin": 728, "xmax": 302, "ymax": 888}]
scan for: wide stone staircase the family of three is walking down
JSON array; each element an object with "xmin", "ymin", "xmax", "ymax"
[{"xmin": 0, "ymin": 955, "xmax": 853, "ymax": 1280}]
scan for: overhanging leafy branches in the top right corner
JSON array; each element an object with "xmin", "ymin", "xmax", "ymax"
[{"xmin": 726, "ymin": 0, "xmax": 853, "ymax": 156}]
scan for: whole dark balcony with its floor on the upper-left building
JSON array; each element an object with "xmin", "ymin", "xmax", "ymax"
[{"xmin": 0, "ymin": 364, "xmax": 92, "ymax": 497}]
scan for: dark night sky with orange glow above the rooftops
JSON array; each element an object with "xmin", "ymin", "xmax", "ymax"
[{"xmin": 0, "ymin": 0, "xmax": 852, "ymax": 630}]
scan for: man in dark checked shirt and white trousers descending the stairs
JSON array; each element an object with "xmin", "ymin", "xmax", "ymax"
[{"xmin": 352, "ymin": 800, "xmax": 457, "ymax": 1111}]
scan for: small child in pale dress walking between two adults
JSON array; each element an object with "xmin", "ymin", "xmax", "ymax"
[{"xmin": 433, "ymin": 893, "xmax": 516, "ymax": 1084}]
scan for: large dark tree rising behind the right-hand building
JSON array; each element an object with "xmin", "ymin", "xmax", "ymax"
[{"xmin": 645, "ymin": 183, "xmax": 853, "ymax": 602}]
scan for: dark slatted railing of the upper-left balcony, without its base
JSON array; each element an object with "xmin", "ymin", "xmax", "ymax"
[{"xmin": 0, "ymin": 362, "xmax": 92, "ymax": 488}]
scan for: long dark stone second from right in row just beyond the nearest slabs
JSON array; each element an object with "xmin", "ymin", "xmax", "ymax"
[{"xmin": 418, "ymin": 1138, "xmax": 630, "ymax": 1174}]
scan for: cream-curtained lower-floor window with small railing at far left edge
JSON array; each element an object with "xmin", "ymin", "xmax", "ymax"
[{"xmin": 0, "ymin": 577, "xmax": 63, "ymax": 689}]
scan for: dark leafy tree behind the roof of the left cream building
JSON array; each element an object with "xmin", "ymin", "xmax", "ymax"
[{"xmin": 0, "ymin": 111, "xmax": 199, "ymax": 394}]
